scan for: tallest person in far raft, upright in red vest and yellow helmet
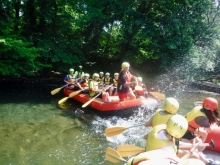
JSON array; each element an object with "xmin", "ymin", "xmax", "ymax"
[{"xmin": 117, "ymin": 62, "xmax": 136, "ymax": 101}]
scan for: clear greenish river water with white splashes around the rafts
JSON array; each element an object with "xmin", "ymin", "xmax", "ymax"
[{"xmin": 0, "ymin": 84, "xmax": 220, "ymax": 165}]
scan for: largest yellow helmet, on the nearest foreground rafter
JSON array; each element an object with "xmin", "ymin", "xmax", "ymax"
[{"xmin": 166, "ymin": 114, "xmax": 188, "ymax": 139}]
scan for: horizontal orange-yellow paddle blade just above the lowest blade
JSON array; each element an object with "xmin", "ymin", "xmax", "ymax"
[{"xmin": 117, "ymin": 144, "xmax": 145, "ymax": 157}]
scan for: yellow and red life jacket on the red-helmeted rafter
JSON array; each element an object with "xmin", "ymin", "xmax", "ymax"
[{"xmin": 186, "ymin": 106, "xmax": 206, "ymax": 132}]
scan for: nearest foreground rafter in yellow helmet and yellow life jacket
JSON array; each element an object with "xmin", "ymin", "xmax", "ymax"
[{"xmin": 127, "ymin": 114, "xmax": 188, "ymax": 165}]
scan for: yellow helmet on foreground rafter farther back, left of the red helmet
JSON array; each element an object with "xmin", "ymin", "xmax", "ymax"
[{"xmin": 163, "ymin": 97, "xmax": 179, "ymax": 113}]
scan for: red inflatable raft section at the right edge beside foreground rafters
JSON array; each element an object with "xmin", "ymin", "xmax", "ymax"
[{"xmin": 205, "ymin": 124, "xmax": 220, "ymax": 152}]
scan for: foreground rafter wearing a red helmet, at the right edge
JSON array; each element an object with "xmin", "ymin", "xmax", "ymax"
[{"xmin": 179, "ymin": 97, "xmax": 220, "ymax": 165}]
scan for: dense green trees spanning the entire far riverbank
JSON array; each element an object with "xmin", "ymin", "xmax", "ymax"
[{"xmin": 0, "ymin": 0, "xmax": 219, "ymax": 76}]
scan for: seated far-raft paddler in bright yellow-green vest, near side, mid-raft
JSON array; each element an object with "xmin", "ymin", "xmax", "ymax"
[{"xmin": 89, "ymin": 73, "xmax": 102, "ymax": 98}]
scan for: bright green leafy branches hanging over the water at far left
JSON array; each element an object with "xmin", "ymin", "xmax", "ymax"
[{"xmin": 0, "ymin": 38, "xmax": 39, "ymax": 77}]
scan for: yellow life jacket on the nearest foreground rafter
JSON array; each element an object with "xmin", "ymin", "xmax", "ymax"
[{"xmin": 146, "ymin": 124, "xmax": 177, "ymax": 153}]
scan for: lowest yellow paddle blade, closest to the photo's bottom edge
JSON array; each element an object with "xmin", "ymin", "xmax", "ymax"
[{"xmin": 105, "ymin": 147, "xmax": 126, "ymax": 163}]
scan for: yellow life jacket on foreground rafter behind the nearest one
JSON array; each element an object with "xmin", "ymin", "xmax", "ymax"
[{"xmin": 152, "ymin": 109, "xmax": 173, "ymax": 127}]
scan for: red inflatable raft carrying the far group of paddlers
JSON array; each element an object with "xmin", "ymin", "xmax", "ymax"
[{"xmin": 64, "ymin": 88, "xmax": 159, "ymax": 114}]
